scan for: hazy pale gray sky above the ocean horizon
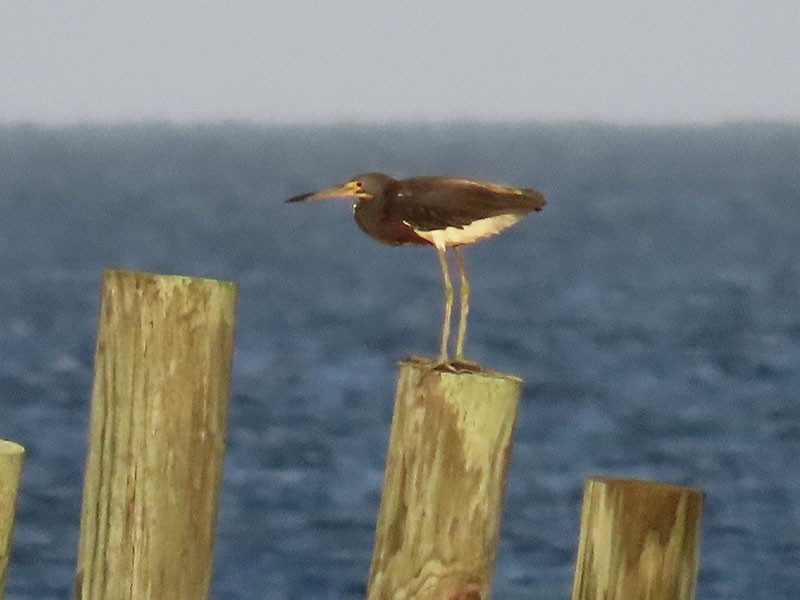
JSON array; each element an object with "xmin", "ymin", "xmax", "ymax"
[{"xmin": 0, "ymin": 0, "xmax": 800, "ymax": 122}]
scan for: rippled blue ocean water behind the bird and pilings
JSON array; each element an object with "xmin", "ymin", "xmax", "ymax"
[{"xmin": 0, "ymin": 123, "xmax": 800, "ymax": 600}]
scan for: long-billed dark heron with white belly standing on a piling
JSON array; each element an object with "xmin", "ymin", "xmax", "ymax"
[{"xmin": 287, "ymin": 172, "xmax": 547, "ymax": 366}]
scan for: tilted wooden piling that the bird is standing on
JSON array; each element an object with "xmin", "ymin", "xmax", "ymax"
[{"xmin": 367, "ymin": 359, "xmax": 522, "ymax": 600}]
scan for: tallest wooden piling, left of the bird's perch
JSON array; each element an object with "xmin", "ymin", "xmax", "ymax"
[{"xmin": 74, "ymin": 270, "xmax": 236, "ymax": 600}]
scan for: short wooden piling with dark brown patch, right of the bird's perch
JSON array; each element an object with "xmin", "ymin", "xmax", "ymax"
[{"xmin": 572, "ymin": 477, "xmax": 704, "ymax": 600}]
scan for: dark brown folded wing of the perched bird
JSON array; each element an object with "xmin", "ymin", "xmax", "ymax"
[{"xmin": 386, "ymin": 177, "xmax": 546, "ymax": 231}]
